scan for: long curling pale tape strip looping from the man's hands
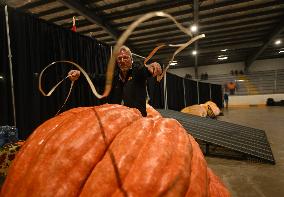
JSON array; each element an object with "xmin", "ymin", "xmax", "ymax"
[{"xmin": 39, "ymin": 12, "xmax": 205, "ymax": 114}]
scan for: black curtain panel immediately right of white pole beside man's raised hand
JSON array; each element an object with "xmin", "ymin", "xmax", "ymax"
[{"xmin": 167, "ymin": 73, "xmax": 185, "ymax": 111}]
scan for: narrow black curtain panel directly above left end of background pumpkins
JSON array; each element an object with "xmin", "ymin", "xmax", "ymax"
[{"xmin": 184, "ymin": 79, "xmax": 198, "ymax": 106}]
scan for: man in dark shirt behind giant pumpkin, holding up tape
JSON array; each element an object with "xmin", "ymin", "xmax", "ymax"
[{"xmin": 68, "ymin": 46, "xmax": 162, "ymax": 117}]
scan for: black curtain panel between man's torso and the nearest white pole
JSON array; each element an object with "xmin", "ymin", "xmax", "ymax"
[{"xmin": 147, "ymin": 78, "xmax": 165, "ymax": 109}]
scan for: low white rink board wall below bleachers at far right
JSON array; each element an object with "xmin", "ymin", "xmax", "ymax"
[{"xmin": 229, "ymin": 94, "xmax": 284, "ymax": 106}]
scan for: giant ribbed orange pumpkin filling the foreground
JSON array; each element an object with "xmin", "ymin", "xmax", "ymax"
[{"xmin": 1, "ymin": 104, "xmax": 229, "ymax": 197}]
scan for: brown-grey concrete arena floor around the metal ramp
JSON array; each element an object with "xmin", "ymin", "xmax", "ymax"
[{"xmin": 206, "ymin": 107, "xmax": 284, "ymax": 197}]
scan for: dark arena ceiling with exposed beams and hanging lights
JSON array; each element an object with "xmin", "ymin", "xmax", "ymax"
[{"xmin": 2, "ymin": 0, "xmax": 284, "ymax": 68}]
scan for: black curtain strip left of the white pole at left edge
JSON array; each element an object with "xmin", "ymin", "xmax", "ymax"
[{"xmin": 0, "ymin": 7, "xmax": 14, "ymax": 125}]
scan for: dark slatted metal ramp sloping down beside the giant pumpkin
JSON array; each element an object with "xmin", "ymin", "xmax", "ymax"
[{"xmin": 158, "ymin": 109, "xmax": 275, "ymax": 164}]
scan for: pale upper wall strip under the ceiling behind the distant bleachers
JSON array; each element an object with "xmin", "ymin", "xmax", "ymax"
[{"xmin": 168, "ymin": 58, "xmax": 284, "ymax": 77}]
